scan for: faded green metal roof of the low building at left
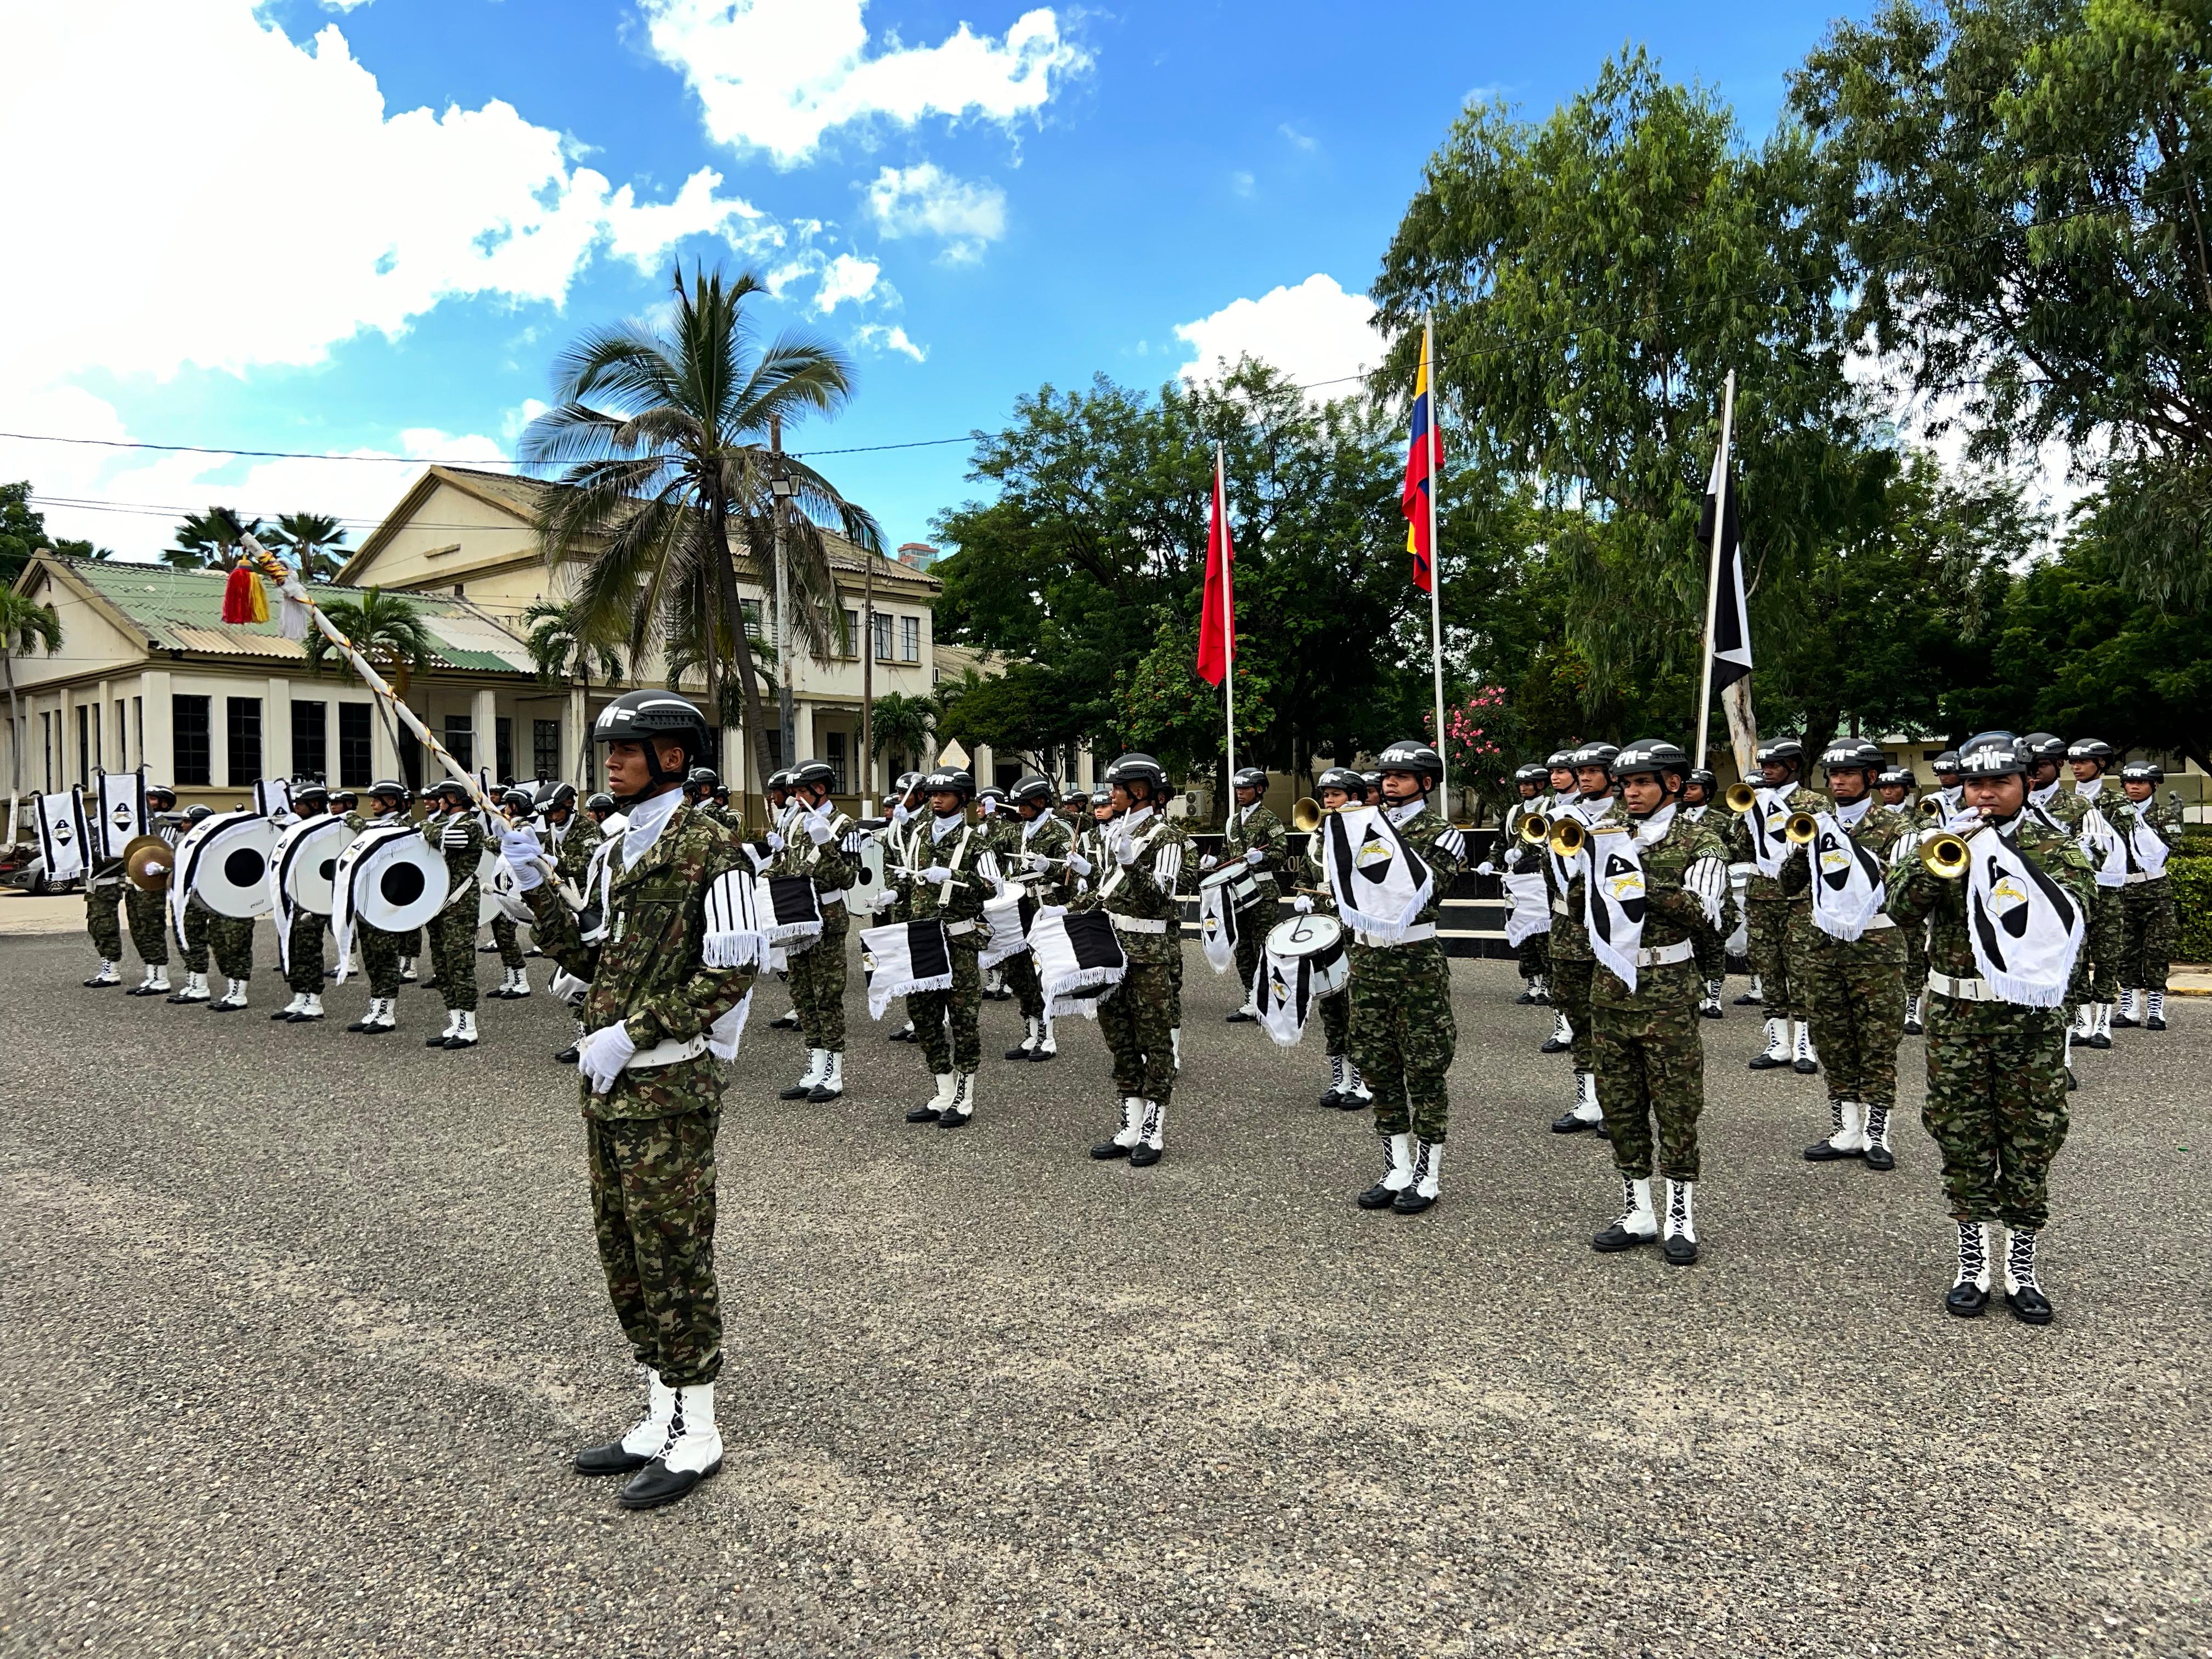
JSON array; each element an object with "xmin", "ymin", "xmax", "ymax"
[{"xmin": 55, "ymin": 557, "xmax": 535, "ymax": 675}]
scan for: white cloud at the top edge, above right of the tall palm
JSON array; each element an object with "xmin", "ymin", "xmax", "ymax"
[{"xmin": 641, "ymin": 0, "xmax": 1091, "ymax": 166}]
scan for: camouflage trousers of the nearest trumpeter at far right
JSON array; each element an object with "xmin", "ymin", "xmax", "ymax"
[{"xmin": 1928, "ymin": 995, "xmax": 2066, "ymax": 1228}]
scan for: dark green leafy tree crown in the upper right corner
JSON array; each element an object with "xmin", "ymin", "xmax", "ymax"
[{"xmin": 1790, "ymin": 0, "xmax": 2212, "ymax": 608}]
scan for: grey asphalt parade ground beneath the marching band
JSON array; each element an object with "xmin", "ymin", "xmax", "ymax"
[{"xmin": 0, "ymin": 929, "xmax": 2212, "ymax": 1659}]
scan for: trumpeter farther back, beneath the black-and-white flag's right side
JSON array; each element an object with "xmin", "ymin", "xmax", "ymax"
[{"xmin": 1728, "ymin": 737, "xmax": 1827, "ymax": 1077}]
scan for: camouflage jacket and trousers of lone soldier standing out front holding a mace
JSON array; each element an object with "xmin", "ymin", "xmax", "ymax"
[{"xmin": 524, "ymin": 805, "xmax": 754, "ymax": 1389}]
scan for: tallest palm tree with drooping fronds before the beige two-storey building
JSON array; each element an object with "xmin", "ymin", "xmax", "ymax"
[{"xmin": 522, "ymin": 266, "xmax": 883, "ymax": 792}]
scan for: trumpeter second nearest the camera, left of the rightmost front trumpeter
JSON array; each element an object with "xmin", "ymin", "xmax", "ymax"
[{"xmin": 1582, "ymin": 739, "xmax": 1728, "ymax": 1267}]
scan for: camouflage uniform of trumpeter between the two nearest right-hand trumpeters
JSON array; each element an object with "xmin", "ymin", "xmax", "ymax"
[{"xmin": 1801, "ymin": 801, "xmax": 1920, "ymax": 1132}]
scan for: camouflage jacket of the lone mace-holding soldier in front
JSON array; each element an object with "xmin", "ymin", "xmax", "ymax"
[{"xmin": 527, "ymin": 808, "xmax": 754, "ymax": 1119}]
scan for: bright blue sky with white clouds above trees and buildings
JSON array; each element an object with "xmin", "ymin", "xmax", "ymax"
[{"xmin": 0, "ymin": 0, "xmax": 1860, "ymax": 557}]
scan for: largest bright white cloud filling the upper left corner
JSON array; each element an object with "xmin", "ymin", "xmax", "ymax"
[{"xmin": 0, "ymin": 0, "xmax": 781, "ymax": 385}]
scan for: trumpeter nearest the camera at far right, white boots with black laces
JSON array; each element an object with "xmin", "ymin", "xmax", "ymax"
[{"xmin": 1889, "ymin": 732, "xmax": 2095, "ymax": 1325}]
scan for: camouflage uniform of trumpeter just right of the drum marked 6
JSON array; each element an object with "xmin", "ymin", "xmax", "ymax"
[{"xmin": 1347, "ymin": 801, "xmax": 1469, "ymax": 1144}]
